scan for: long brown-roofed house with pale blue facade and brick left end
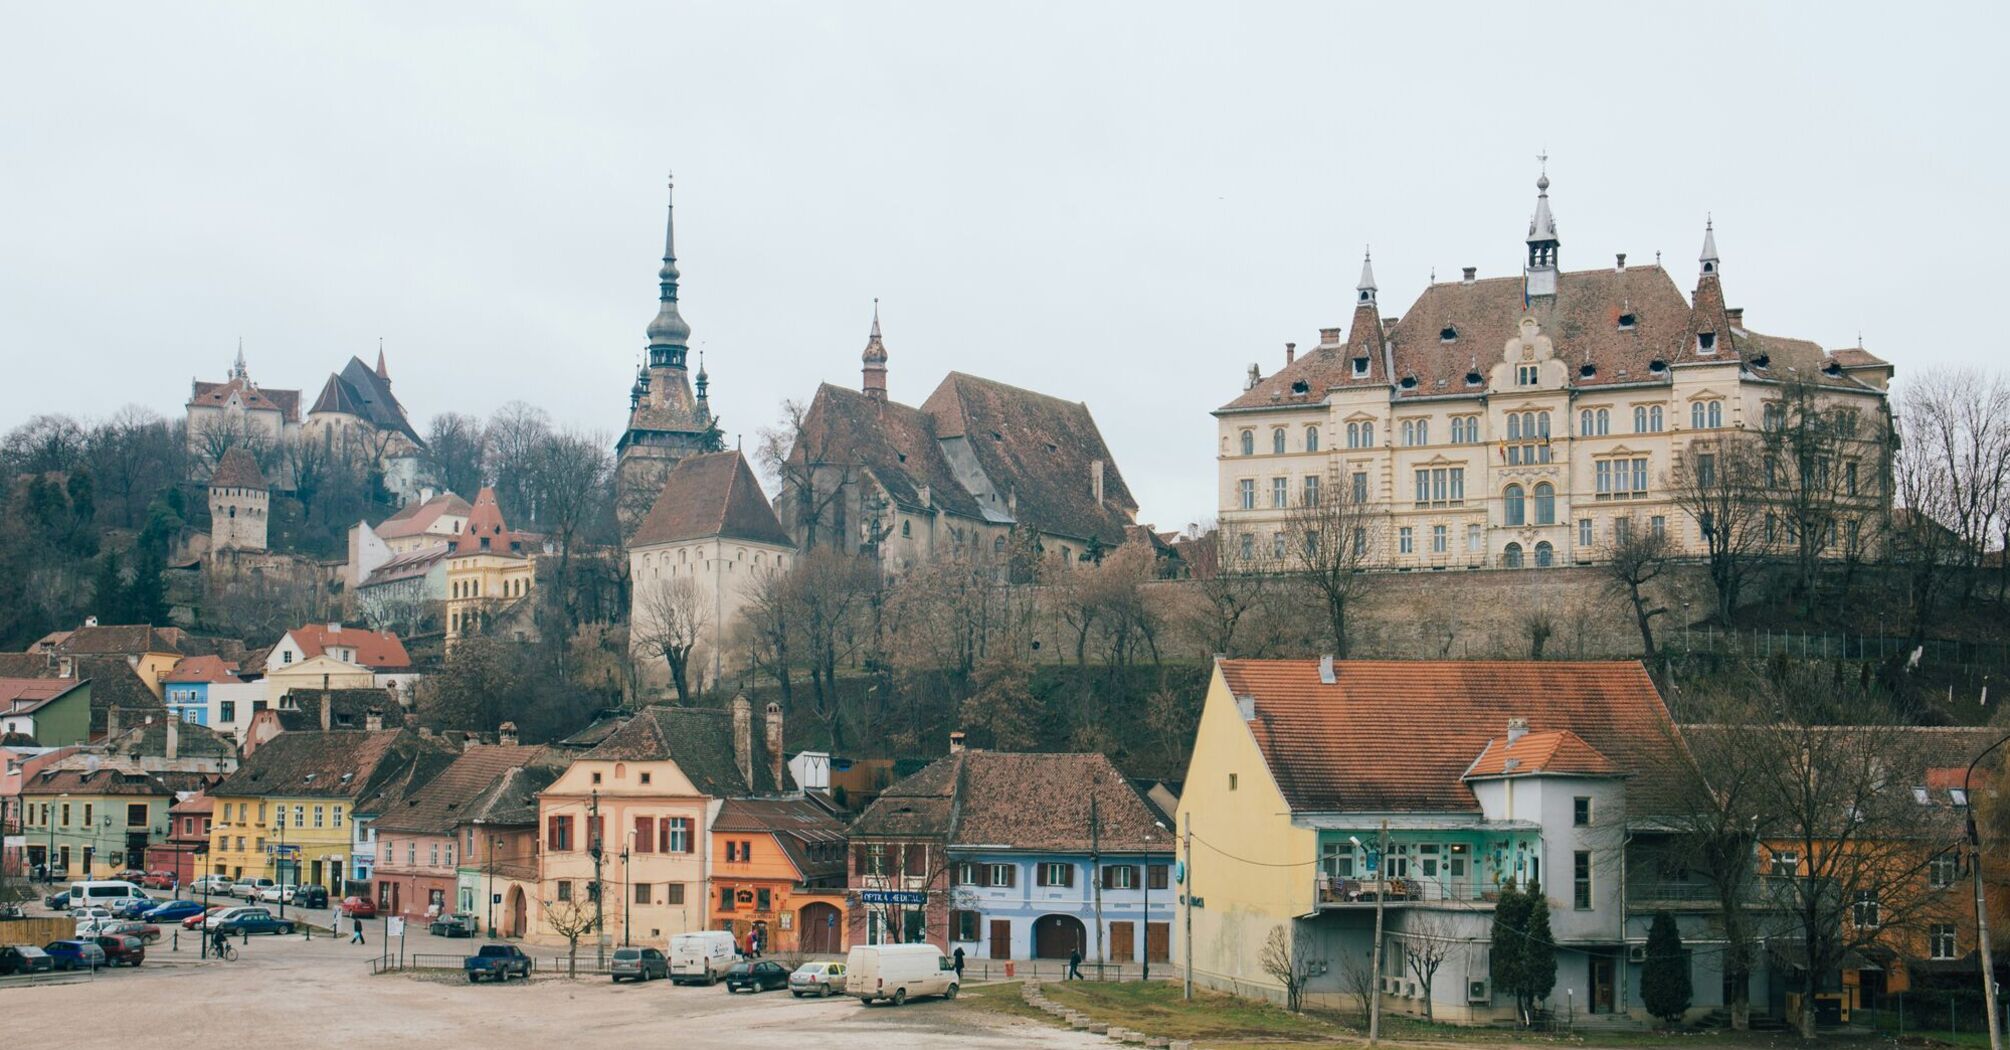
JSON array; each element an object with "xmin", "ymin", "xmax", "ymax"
[{"xmin": 850, "ymin": 748, "xmax": 1178, "ymax": 968}]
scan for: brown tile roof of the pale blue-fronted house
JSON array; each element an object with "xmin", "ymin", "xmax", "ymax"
[{"xmin": 852, "ymin": 750, "xmax": 1174, "ymax": 853}]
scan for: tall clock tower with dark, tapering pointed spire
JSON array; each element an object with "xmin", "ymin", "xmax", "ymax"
[{"xmin": 615, "ymin": 174, "xmax": 724, "ymax": 537}]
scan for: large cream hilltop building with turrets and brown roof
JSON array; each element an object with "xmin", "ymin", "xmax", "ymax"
[{"xmin": 1214, "ymin": 175, "xmax": 1891, "ymax": 569}]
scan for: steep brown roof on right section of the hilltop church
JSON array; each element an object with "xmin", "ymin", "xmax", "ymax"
[{"xmin": 921, "ymin": 372, "xmax": 1138, "ymax": 547}]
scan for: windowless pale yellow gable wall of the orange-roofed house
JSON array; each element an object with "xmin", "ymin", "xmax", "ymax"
[{"xmin": 1172, "ymin": 668, "xmax": 1319, "ymax": 994}]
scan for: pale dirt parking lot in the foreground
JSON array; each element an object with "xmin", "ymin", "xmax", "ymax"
[{"xmin": 0, "ymin": 937, "xmax": 1106, "ymax": 1050}]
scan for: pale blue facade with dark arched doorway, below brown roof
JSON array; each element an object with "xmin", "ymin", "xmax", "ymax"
[{"xmin": 949, "ymin": 851, "xmax": 1178, "ymax": 966}]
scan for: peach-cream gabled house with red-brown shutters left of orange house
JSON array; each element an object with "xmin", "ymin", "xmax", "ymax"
[{"xmin": 538, "ymin": 696, "xmax": 786, "ymax": 947}]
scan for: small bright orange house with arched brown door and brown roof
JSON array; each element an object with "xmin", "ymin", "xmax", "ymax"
[{"xmin": 712, "ymin": 797, "xmax": 846, "ymax": 955}]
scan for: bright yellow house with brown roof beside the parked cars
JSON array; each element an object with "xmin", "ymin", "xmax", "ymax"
[{"xmin": 209, "ymin": 730, "xmax": 446, "ymax": 895}]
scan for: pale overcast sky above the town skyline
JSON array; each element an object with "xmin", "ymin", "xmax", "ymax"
[{"xmin": 0, "ymin": 2, "xmax": 2010, "ymax": 527}]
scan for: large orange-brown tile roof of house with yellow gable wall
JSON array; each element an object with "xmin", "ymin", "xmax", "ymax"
[{"xmin": 1218, "ymin": 660, "xmax": 1688, "ymax": 817}]
